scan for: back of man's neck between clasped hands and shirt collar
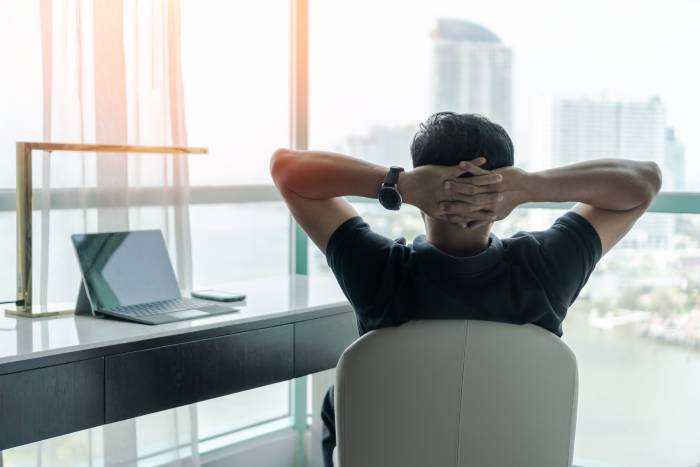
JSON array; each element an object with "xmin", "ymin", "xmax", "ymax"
[{"xmin": 425, "ymin": 217, "xmax": 491, "ymax": 256}]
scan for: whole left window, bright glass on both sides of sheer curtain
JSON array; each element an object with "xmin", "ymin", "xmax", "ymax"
[{"xmin": 0, "ymin": 0, "xmax": 290, "ymax": 465}]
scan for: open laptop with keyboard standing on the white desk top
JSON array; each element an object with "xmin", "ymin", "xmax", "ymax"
[{"xmin": 71, "ymin": 230, "xmax": 238, "ymax": 324}]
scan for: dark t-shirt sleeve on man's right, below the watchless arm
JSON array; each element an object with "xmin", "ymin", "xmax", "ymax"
[{"xmin": 532, "ymin": 212, "xmax": 602, "ymax": 308}]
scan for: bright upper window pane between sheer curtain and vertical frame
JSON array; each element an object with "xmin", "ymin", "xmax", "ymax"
[{"xmin": 182, "ymin": 0, "xmax": 290, "ymax": 185}]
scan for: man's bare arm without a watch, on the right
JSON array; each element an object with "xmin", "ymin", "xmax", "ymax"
[{"xmin": 442, "ymin": 159, "xmax": 661, "ymax": 254}]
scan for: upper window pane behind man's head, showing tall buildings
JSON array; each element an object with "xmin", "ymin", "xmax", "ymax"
[{"xmin": 310, "ymin": 0, "xmax": 700, "ymax": 191}]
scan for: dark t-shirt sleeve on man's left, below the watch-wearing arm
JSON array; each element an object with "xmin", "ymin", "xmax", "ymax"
[{"xmin": 326, "ymin": 217, "xmax": 402, "ymax": 314}]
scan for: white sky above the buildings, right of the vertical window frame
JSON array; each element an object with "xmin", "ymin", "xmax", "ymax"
[{"xmin": 311, "ymin": 0, "xmax": 700, "ymax": 186}]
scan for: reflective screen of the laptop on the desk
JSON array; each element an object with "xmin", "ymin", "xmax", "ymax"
[{"xmin": 71, "ymin": 230, "xmax": 180, "ymax": 310}]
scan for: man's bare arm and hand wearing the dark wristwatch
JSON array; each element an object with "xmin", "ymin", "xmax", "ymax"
[{"xmin": 270, "ymin": 149, "xmax": 502, "ymax": 252}]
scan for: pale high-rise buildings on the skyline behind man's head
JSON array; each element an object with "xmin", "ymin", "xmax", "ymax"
[{"xmin": 344, "ymin": 18, "xmax": 690, "ymax": 191}]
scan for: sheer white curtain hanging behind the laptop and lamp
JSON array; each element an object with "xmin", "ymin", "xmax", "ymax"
[{"xmin": 34, "ymin": 0, "xmax": 199, "ymax": 465}]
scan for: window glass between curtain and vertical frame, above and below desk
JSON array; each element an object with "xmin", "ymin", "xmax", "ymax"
[{"xmin": 182, "ymin": 0, "xmax": 290, "ymax": 454}]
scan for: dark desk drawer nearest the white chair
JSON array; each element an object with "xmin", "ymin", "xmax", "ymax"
[{"xmin": 294, "ymin": 312, "xmax": 358, "ymax": 378}]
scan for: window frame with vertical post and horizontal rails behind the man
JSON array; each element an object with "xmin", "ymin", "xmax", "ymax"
[{"xmin": 0, "ymin": 0, "xmax": 700, "ymax": 466}]
